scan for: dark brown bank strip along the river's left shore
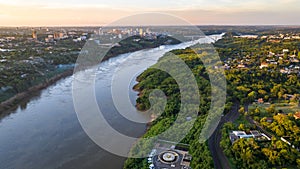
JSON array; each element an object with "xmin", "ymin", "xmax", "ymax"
[{"xmin": 0, "ymin": 69, "xmax": 73, "ymax": 115}]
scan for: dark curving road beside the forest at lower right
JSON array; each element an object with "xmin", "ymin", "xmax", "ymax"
[{"xmin": 208, "ymin": 103, "xmax": 239, "ymax": 169}]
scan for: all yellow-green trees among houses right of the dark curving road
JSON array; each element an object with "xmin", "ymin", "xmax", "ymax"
[{"xmin": 216, "ymin": 36, "xmax": 300, "ymax": 168}]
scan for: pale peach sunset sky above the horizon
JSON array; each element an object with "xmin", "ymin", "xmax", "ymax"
[{"xmin": 0, "ymin": 0, "xmax": 300, "ymax": 26}]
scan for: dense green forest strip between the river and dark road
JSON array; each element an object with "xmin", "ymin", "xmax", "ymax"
[{"xmin": 124, "ymin": 48, "xmax": 214, "ymax": 169}]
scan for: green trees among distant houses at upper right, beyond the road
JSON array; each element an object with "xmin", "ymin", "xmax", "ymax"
[{"xmin": 215, "ymin": 36, "xmax": 300, "ymax": 103}]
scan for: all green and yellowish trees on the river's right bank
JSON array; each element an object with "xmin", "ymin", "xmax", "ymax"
[{"xmin": 125, "ymin": 31, "xmax": 300, "ymax": 168}]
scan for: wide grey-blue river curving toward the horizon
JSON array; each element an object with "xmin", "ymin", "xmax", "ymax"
[{"xmin": 0, "ymin": 34, "xmax": 221, "ymax": 169}]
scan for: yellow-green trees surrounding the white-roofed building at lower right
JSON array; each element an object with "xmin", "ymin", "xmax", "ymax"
[{"xmin": 220, "ymin": 119, "xmax": 300, "ymax": 168}]
